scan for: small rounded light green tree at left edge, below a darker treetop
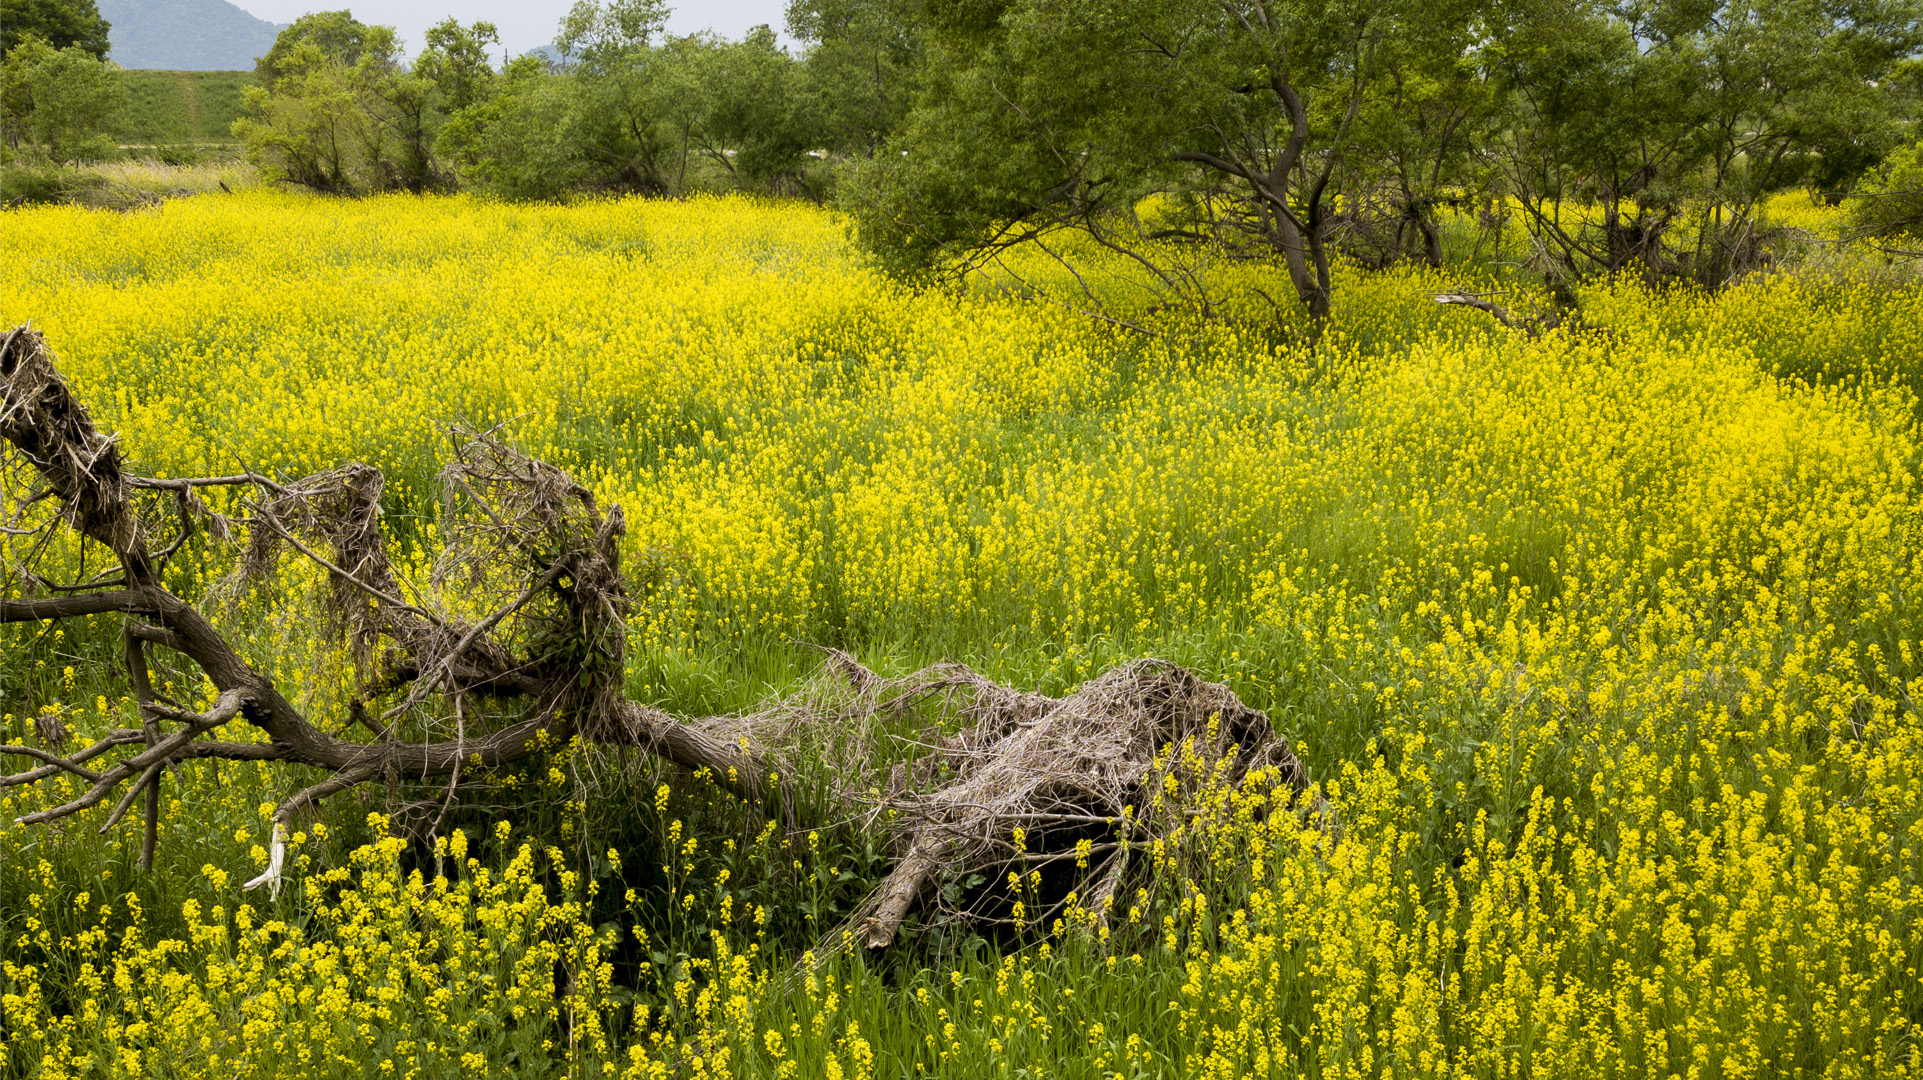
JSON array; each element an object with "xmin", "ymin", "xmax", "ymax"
[{"xmin": 0, "ymin": 38, "xmax": 127, "ymax": 161}]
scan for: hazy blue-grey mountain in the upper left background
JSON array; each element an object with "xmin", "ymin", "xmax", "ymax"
[{"xmin": 98, "ymin": 0, "xmax": 285, "ymax": 71}]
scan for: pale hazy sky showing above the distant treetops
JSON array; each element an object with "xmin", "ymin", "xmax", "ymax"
[{"xmin": 233, "ymin": 0, "xmax": 792, "ymax": 56}]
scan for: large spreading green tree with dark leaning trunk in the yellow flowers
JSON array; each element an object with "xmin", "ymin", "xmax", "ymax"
[{"xmin": 850, "ymin": 0, "xmax": 1456, "ymax": 323}]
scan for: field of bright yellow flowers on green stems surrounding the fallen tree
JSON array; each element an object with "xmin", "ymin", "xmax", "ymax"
[{"xmin": 0, "ymin": 190, "xmax": 1923, "ymax": 1080}]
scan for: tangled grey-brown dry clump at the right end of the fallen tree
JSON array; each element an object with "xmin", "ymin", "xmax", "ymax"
[{"xmin": 788, "ymin": 653, "xmax": 1308, "ymax": 949}]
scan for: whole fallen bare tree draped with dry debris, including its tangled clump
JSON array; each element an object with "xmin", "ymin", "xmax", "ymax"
[{"xmin": 0, "ymin": 329, "xmax": 1308, "ymax": 949}]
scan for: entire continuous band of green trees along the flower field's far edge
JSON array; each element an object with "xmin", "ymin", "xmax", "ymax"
[{"xmin": 206, "ymin": 0, "xmax": 1923, "ymax": 303}]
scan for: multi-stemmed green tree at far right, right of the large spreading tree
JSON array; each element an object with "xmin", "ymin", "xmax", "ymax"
[{"xmin": 1483, "ymin": 0, "xmax": 1923, "ymax": 284}]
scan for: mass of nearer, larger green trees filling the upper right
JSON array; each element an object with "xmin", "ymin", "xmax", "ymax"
[{"xmin": 846, "ymin": 0, "xmax": 1923, "ymax": 307}]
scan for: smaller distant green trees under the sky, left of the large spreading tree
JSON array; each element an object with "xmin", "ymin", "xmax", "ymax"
[{"xmin": 235, "ymin": 0, "xmax": 815, "ymax": 198}]
